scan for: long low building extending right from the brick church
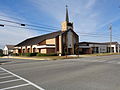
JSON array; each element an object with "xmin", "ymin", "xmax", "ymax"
[{"xmin": 79, "ymin": 42, "xmax": 120, "ymax": 54}]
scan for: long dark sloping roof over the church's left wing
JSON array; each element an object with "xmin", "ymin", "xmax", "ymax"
[{"xmin": 16, "ymin": 31, "xmax": 63, "ymax": 46}]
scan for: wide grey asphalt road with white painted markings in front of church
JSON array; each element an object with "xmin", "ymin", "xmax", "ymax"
[{"xmin": 0, "ymin": 55, "xmax": 120, "ymax": 90}]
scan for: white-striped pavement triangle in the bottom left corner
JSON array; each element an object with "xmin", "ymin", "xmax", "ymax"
[{"xmin": 0, "ymin": 67, "xmax": 44, "ymax": 90}]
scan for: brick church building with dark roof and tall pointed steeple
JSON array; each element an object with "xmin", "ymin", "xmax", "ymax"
[{"xmin": 14, "ymin": 7, "xmax": 79, "ymax": 55}]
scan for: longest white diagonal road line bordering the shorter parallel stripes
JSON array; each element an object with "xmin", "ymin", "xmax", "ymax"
[{"xmin": 0, "ymin": 67, "xmax": 45, "ymax": 90}]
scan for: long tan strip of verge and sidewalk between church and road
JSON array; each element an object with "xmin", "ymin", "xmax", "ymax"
[{"xmin": 0, "ymin": 53, "xmax": 120, "ymax": 60}]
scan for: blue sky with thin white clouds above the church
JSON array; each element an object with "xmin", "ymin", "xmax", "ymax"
[{"xmin": 0, "ymin": 0, "xmax": 120, "ymax": 48}]
